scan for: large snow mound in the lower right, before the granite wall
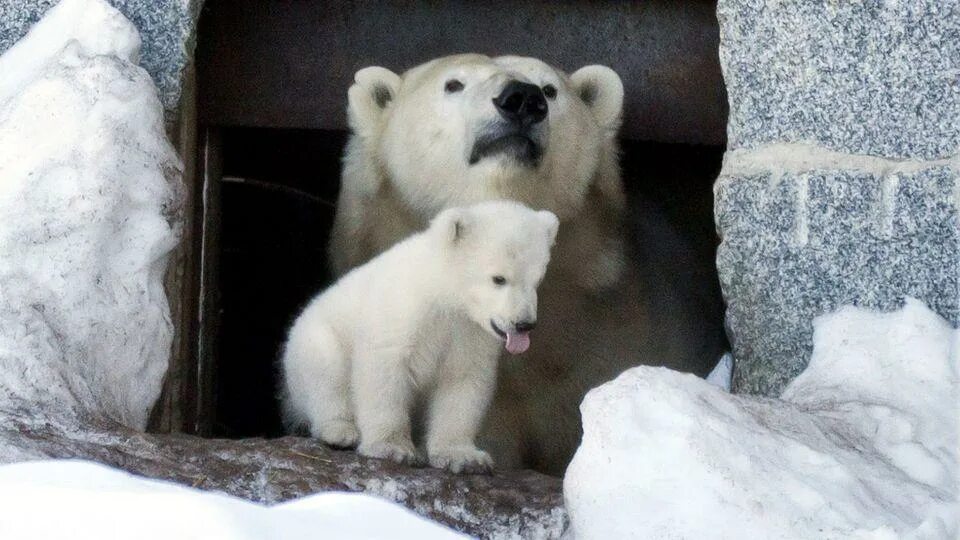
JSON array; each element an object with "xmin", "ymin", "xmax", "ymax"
[{"xmin": 564, "ymin": 300, "xmax": 960, "ymax": 539}]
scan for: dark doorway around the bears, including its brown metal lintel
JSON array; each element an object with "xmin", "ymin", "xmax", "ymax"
[{"xmin": 181, "ymin": 0, "xmax": 726, "ymax": 437}]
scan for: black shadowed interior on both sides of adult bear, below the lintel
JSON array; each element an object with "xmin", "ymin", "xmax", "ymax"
[{"xmin": 213, "ymin": 128, "xmax": 723, "ymax": 437}]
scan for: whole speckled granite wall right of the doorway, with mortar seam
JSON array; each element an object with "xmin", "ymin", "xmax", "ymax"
[{"xmin": 714, "ymin": 0, "xmax": 960, "ymax": 396}]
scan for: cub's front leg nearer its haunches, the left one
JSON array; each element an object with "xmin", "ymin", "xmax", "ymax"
[{"xmin": 353, "ymin": 346, "xmax": 419, "ymax": 464}]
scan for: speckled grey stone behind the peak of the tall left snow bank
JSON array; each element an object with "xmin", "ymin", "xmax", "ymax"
[{"xmin": 0, "ymin": 0, "xmax": 203, "ymax": 113}]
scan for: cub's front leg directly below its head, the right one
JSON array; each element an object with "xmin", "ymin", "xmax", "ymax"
[{"xmin": 427, "ymin": 336, "xmax": 499, "ymax": 473}]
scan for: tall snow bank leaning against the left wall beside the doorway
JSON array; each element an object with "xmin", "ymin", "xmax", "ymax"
[{"xmin": 0, "ymin": 0, "xmax": 181, "ymax": 428}]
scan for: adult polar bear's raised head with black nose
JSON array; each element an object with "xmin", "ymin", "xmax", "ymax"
[{"xmin": 348, "ymin": 54, "xmax": 623, "ymax": 218}]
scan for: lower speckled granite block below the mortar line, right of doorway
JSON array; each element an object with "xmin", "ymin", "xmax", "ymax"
[{"xmin": 715, "ymin": 165, "xmax": 960, "ymax": 395}]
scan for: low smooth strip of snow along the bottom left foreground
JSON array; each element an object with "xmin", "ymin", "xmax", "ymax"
[{"xmin": 0, "ymin": 460, "xmax": 466, "ymax": 540}]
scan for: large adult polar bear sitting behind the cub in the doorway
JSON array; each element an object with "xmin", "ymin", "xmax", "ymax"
[{"xmin": 330, "ymin": 54, "xmax": 723, "ymax": 473}]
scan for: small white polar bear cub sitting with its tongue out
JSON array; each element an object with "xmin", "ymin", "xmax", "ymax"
[{"xmin": 282, "ymin": 201, "xmax": 559, "ymax": 472}]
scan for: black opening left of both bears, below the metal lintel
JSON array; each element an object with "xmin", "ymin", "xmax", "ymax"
[{"xmin": 212, "ymin": 128, "xmax": 346, "ymax": 437}]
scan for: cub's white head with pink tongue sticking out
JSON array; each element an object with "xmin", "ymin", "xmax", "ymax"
[{"xmin": 430, "ymin": 201, "xmax": 559, "ymax": 354}]
